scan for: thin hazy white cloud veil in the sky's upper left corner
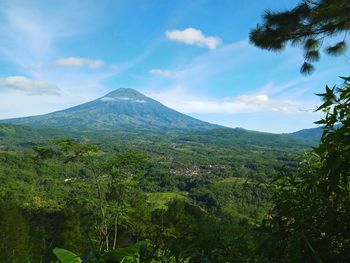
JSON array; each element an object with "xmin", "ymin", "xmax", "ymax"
[{"xmin": 0, "ymin": 0, "xmax": 83, "ymax": 70}]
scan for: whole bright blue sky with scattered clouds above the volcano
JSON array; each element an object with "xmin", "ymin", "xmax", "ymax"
[{"xmin": 0, "ymin": 0, "xmax": 350, "ymax": 133}]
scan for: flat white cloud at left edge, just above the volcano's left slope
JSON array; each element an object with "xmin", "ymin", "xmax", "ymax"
[{"xmin": 0, "ymin": 76, "xmax": 60, "ymax": 95}]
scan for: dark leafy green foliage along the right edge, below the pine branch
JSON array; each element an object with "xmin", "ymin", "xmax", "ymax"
[{"xmin": 261, "ymin": 78, "xmax": 350, "ymax": 262}]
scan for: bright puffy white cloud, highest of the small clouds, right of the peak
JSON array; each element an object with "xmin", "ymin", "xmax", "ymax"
[{"xmin": 165, "ymin": 27, "xmax": 221, "ymax": 49}]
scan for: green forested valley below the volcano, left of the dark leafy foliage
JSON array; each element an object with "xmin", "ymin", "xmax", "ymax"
[{"xmin": 0, "ymin": 90, "xmax": 318, "ymax": 263}]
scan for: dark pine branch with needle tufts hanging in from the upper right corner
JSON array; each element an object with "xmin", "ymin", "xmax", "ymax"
[{"xmin": 250, "ymin": 0, "xmax": 350, "ymax": 74}]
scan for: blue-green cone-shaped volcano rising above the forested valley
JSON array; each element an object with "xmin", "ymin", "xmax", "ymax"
[{"xmin": 1, "ymin": 88, "xmax": 219, "ymax": 132}]
